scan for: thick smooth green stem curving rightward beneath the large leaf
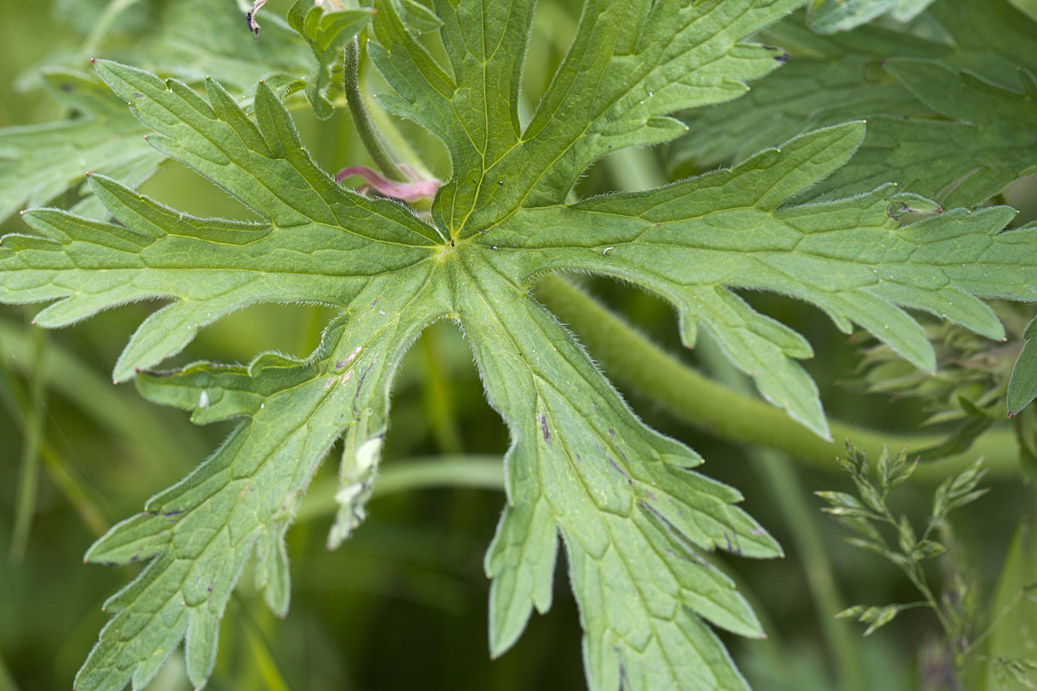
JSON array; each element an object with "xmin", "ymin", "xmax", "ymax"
[{"xmin": 536, "ymin": 276, "xmax": 1018, "ymax": 481}]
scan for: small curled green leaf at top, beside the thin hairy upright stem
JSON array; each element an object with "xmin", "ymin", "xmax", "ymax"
[{"xmin": 288, "ymin": 0, "xmax": 371, "ymax": 119}]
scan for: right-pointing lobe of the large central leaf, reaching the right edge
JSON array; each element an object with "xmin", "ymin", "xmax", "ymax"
[{"xmin": 477, "ymin": 123, "xmax": 1037, "ymax": 435}]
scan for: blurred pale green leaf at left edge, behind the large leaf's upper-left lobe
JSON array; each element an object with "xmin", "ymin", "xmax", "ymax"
[{"xmin": 0, "ymin": 72, "xmax": 163, "ymax": 221}]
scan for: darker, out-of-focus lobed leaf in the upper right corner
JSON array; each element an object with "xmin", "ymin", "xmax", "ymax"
[{"xmin": 672, "ymin": 0, "xmax": 1037, "ymax": 206}]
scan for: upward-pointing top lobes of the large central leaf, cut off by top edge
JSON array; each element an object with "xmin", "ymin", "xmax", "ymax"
[{"xmin": 371, "ymin": 0, "xmax": 796, "ymax": 238}]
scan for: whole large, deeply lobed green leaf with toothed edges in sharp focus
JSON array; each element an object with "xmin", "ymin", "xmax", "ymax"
[{"xmin": 0, "ymin": 0, "xmax": 1037, "ymax": 690}]
